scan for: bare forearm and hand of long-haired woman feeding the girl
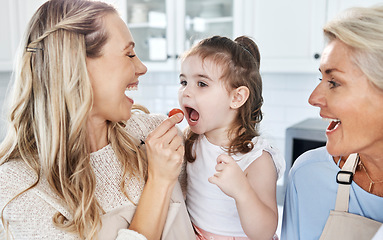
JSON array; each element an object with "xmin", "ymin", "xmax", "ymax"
[{"xmin": 129, "ymin": 114, "xmax": 184, "ymax": 240}]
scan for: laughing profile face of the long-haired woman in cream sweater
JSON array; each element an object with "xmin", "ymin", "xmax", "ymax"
[{"xmin": 87, "ymin": 14, "xmax": 147, "ymax": 122}]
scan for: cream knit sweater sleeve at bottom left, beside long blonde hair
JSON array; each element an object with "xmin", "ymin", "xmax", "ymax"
[{"xmin": 0, "ymin": 160, "xmax": 78, "ymax": 240}]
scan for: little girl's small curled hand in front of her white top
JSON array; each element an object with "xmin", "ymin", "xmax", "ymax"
[{"xmin": 209, "ymin": 154, "xmax": 250, "ymax": 199}]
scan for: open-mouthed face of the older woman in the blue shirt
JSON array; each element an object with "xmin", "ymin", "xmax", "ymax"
[{"xmin": 309, "ymin": 40, "xmax": 383, "ymax": 156}]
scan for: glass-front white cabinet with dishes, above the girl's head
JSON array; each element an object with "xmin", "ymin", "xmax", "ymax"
[{"xmin": 120, "ymin": 0, "xmax": 245, "ymax": 71}]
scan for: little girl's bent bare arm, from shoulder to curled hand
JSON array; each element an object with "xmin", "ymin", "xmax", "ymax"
[{"xmin": 209, "ymin": 152, "xmax": 278, "ymax": 240}]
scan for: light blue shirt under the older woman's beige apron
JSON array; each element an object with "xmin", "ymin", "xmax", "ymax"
[{"xmin": 281, "ymin": 147, "xmax": 383, "ymax": 240}]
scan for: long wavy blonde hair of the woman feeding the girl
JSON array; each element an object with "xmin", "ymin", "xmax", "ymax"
[{"xmin": 0, "ymin": 0, "xmax": 147, "ymax": 239}]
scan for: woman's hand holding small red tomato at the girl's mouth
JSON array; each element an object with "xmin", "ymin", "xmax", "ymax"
[{"xmin": 145, "ymin": 113, "xmax": 184, "ymax": 184}]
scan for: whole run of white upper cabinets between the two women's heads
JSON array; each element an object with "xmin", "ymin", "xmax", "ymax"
[{"xmin": 123, "ymin": 0, "xmax": 327, "ymax": 73}]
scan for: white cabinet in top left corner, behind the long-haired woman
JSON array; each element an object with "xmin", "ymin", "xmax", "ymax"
[{"xmin": 0, "ymin": 0, "xmax": 44, "ymax": 72}]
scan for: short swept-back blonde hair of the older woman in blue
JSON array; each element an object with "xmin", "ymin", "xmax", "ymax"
[{"xmin": 323, "ymin": 5, "xmax": 383, "ymax": 90}]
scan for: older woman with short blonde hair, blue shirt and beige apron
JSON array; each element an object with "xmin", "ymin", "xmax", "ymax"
[{"xmin": 282, "ymin": 6, "xmax": 383, "ymax": 240}]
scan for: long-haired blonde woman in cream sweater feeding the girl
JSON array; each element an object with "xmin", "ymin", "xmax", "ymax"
[{"xmin": 0, "ymin": 0, "xmax": 194, "ymax": 240}]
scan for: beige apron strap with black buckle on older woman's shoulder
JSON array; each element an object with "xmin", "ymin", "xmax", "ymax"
[{"xmin": 335, "ymin": 153, "xmax": 359, "ymax": 212}]
